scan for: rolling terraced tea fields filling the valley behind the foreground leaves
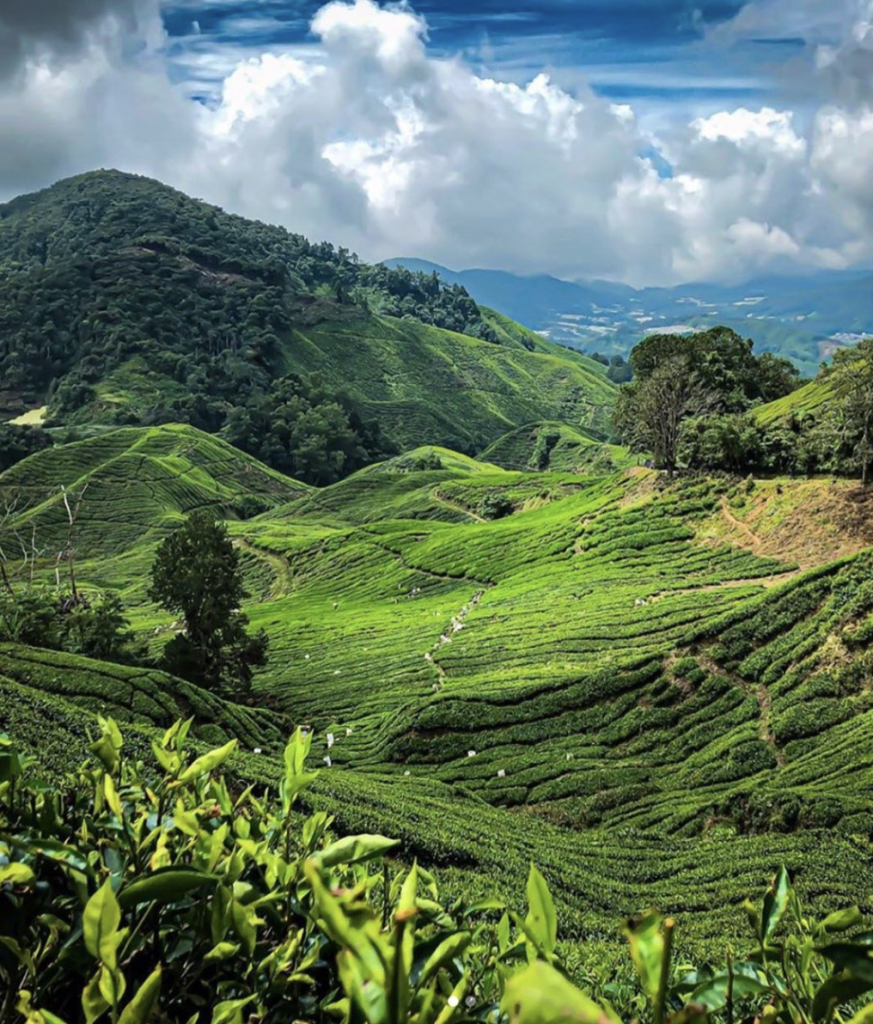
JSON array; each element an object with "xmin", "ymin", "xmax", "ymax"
[{"xmin": 0, "ymin": 427, "xmax": 873, "ymax": 949}]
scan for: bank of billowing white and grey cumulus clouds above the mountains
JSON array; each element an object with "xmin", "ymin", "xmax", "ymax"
[{"xmin": 0, "ymin": 0, "xmax": 873, "ymax": 284}]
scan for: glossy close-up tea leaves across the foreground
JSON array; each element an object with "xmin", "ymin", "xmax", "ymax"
[{"xmin": 0, "ymin": 719, "xmax": 873, "ymax": 1024}]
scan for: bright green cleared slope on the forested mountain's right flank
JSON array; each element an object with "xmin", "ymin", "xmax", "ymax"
[{"xmin": 287, "ymin": 309, "xmax": 615, "ymax": 450}]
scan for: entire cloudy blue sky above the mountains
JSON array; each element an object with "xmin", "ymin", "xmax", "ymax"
[{"xmin": 0, "ymin": 0, "xmax": 873, "ymax": 286}]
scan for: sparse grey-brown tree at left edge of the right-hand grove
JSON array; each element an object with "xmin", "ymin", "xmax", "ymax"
[{"xmin": 615, "ymin": 355, "xmax": 712, "ymax": 476}]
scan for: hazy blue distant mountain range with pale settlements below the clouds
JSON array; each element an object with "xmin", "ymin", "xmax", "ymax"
[{"xmin": 386, "ymin": 257, "xmax": 873, "ymax": 376}]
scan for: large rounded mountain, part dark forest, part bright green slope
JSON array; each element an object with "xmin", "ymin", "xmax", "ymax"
[{"xmin": 0, "ymin": 171, "xmax": 614, "ymax": 458}]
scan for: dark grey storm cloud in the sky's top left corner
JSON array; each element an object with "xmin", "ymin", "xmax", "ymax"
[{"xmin": 0, "ymin": 0, "xmax": 139, "ymax": 77}]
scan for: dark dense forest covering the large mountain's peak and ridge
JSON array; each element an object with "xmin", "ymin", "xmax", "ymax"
[{"xmin": 0, "ymin": 172, "xmax": 496, "ymax": 430}]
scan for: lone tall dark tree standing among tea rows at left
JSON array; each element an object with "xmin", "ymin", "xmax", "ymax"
[{"xmin": 148, "ymin": 509, "xmax": 268, "ymax": 690}]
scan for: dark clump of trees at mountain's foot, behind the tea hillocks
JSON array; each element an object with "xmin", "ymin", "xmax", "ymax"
[{"xmin": 222, "ymin": 375, "xmax": 396, "ymax": 485}]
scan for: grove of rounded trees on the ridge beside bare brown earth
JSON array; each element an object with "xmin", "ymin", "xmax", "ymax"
[{"xmin": 615, "ymin": 328, "xmax": 800, "ymax": 473}]
